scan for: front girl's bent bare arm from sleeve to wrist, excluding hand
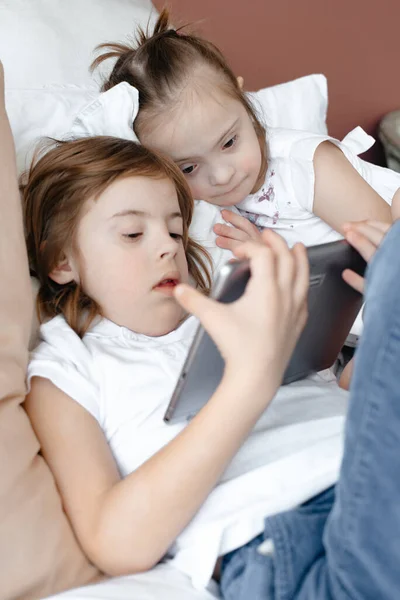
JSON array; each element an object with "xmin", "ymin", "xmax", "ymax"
[{"xmin": 26, "ymin": 377, "xmax": 282, "ymax": 575}]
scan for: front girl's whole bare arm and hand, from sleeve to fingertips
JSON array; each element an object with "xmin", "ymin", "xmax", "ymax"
[{"xmin": 27, "ymin": 232, "xmax": 308, "ymax": 575}]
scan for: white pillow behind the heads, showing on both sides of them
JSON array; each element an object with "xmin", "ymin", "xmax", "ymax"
[{"xmin": 6, "ymin": 75, "xmax": 327, "ymax": 171}]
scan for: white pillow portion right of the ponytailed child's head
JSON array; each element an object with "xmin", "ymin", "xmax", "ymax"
[{"xmin": 249, "ymin": 75, "xmax": 328, "ymax": 135}]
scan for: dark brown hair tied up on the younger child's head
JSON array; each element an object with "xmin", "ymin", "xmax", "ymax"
[{"xmin": 91, "ymin": 8, "xmax": 267, "ymax": 187}]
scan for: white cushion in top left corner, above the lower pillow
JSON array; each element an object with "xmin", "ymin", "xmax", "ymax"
[{"xmin": 0, "ymin": 0, "xmax": 157, "ymax": 89}]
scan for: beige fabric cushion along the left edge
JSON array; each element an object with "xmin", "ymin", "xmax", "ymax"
[{"xmin": 0, "ymin": 62, "xmax": 98, "ymax": 600}]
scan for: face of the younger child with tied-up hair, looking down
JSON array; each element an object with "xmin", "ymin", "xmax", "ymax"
[{"xmin": 139, "ymin": 87, "xmax": 261, "ymax": 206}]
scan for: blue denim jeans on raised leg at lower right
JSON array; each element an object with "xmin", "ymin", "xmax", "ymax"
[{"xmin": 221, "ymin": 222, "xmax": 400, "ymax": 600}]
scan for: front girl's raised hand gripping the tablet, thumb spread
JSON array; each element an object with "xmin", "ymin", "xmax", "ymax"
[{"xmin": 176, "ymin": 231, "xmax": 309, "ymax": 392}]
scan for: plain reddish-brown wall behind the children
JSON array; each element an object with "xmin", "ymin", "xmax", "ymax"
[{"xmin": 154, "ymin": 0, "xmax": 400, "ymax": 162}]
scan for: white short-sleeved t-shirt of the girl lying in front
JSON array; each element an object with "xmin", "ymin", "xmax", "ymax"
[{"xmin": 28, "ymin": 316, "xmax": 347, "ymax": 587}]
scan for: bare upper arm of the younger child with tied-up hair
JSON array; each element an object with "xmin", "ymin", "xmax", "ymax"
[{"xmin": 313, "ymin": 142, "xmax": 392, "ymax": 234}]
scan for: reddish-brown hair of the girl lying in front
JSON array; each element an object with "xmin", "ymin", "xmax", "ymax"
[{"xmin": 21, "ymin": 137, "xmax": 211, "ymax": 337}]
